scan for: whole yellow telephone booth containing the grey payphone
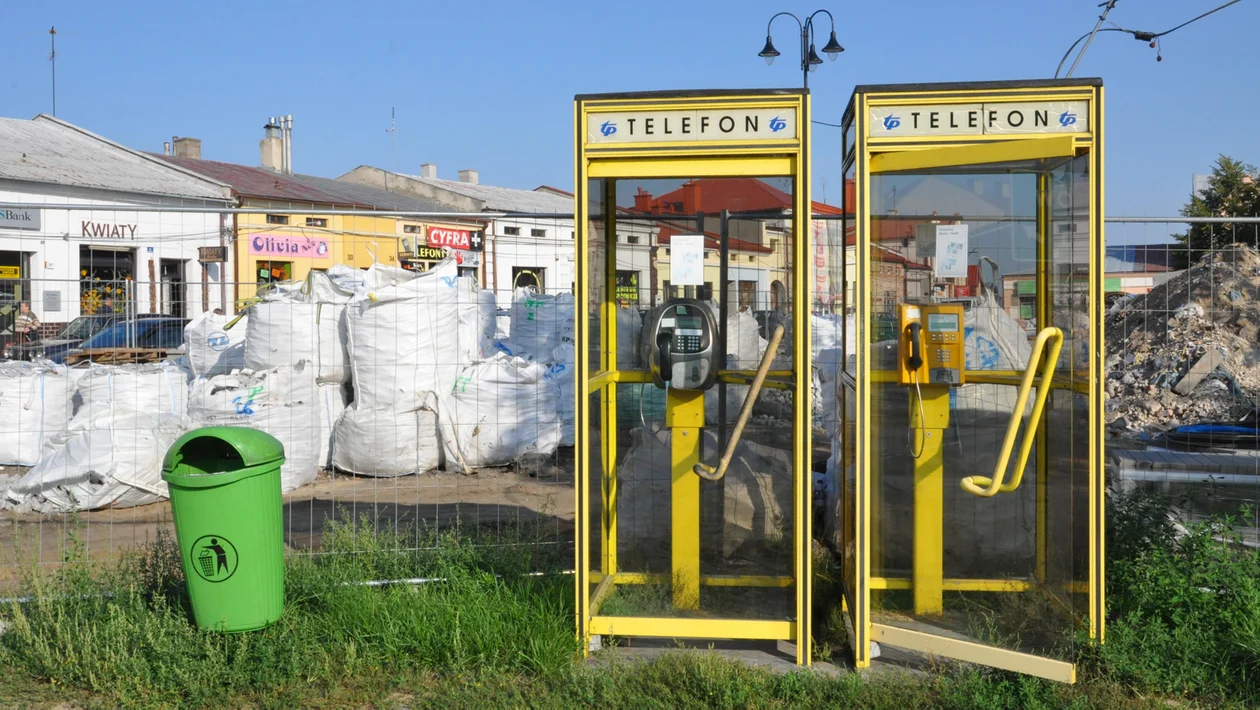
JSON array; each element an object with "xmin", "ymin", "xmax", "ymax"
[{"xmin": 575, "ymin": 91, "xmax": 811, "ymax": 665}]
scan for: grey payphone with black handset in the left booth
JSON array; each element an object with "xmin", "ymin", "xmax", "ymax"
[{"xmin": 639, "ymin": 299, "xmax": 717, "ymax": 390}]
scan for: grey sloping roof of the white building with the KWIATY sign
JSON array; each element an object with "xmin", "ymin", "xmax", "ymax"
[{"xmin": 0, "ymin": 113, "xmax": 232, "ymax": 202}]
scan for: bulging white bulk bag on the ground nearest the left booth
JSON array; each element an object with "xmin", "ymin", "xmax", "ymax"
[{"xmin": 444, "ymin": 353, "xmax": 561, "ymax": 468}]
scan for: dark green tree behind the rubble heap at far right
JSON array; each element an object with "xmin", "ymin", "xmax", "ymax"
[{"xmin": 1173, "ymin": 155, "xmax": 1260, "ymax": 267}]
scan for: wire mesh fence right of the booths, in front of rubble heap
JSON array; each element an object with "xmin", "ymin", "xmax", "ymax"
[{"xmin": 1104, "ymin": 218, "xmax": 1260, "ymax": 545}]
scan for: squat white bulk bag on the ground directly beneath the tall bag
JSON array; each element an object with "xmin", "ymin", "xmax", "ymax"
[{"xmin": 333, "ymin": 406, "xmax": 441, "ymax": 478}]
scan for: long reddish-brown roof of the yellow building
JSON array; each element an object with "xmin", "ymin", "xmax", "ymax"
[{"xmin": 155, "ymin": 155, "xmax": 455, "ymax": 212}]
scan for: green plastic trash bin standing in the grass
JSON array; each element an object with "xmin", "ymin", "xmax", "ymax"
[{"xmin": 161, "ymin": 426, "xmax": 285, "ymax": 632}]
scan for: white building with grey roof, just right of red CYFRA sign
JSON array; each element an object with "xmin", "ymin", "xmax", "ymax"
[{"xmin": 339, "ymin": 163, "xmax": 656, "ymax": 308}]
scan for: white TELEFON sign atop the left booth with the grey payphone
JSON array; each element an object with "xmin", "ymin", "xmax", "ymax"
[{"xmin": 586, "ymin": 108, "xmax": 796, "ymax": 145}]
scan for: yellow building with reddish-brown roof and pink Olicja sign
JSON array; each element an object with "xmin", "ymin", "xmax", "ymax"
[{"xmin": 156, "ymin": 156, "xmax": 484, "ymax": 310}]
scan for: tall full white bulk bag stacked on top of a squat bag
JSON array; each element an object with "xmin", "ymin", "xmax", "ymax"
[{"xmin": 347, "ymin": 260, "xmax": 470, "ymax": 411}]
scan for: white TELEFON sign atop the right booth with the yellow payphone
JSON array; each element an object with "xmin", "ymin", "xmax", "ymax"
[{"xmin": 869, "ymin": 101, "xmax": 1090, "ymax": 139}]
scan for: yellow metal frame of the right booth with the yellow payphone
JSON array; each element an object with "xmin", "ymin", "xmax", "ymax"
[{"xmin": 840, "ymin": 79, "xmax": 1105, "ymax": 682}]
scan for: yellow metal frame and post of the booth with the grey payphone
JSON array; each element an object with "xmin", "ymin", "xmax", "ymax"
[{"xmin": 573, "ymin": 91, "xmax": 813, "ymax": 666}]
